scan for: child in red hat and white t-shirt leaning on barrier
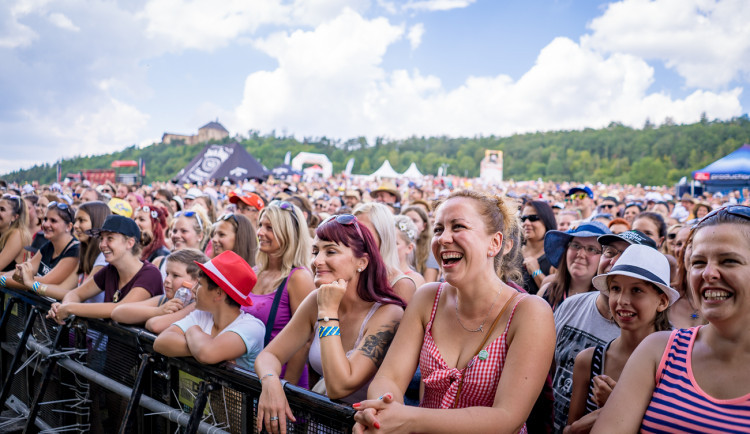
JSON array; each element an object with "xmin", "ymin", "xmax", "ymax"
[{"xmin": 154, "ymin": 250, "xmax": 266, "ymax": 370}]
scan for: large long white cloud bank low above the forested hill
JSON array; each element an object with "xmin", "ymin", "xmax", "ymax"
[{"xmin": 237, "ymin": 21, "xmax": 742, "ymax": 142}]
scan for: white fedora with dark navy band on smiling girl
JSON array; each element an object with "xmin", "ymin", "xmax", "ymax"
[{"xmin": 591, "ymin": 244, "xmax": 680, "ymax": 306}]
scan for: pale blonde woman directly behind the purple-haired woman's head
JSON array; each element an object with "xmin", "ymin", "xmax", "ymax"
[{"xmin": 352, "ymin": 202, "xmax": 417, "ymax": 304}]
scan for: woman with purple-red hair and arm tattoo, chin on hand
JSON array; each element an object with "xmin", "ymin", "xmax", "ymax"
[{"xmin": 255, "ymin": 214, "xmax": 406, "ymax": 433}]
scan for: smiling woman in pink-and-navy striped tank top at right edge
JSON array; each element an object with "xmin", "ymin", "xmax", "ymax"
[{"xmin": 593, "ymin": 205, "xmax": 750, "ymax": 433}]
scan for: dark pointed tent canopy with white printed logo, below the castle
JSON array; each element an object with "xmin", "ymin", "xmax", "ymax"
[{"xmin": 176, "ymin": 143, "xmax": 268, "ymax": 183}]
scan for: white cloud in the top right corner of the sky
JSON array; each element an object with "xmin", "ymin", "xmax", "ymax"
[{"xmin": 582, "ymin": 0, "xmax": 750, "ymax": 89}]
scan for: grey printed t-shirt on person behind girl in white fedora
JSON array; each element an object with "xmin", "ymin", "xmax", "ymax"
[{"xmin": 552, "ymin": 291, "xmax": 620, "ymax": 432}]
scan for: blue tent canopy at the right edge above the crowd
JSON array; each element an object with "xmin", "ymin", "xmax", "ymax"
[{"xmin": 693, "ymin": 144, "xmax": 750, "ymax": 191}]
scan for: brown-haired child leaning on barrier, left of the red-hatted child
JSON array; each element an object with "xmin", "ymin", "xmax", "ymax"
[{"xmin": 112, "ymin": 249, "xmax": 208, "ymax": 334}]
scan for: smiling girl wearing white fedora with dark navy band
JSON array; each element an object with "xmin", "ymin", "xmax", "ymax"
[{"xmin": 568, "ymin": 245, "xmax": 679, "ymax": 432}]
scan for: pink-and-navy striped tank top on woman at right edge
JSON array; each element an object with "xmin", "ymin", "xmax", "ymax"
[{"xmin": 641, "ymin": 326, "xmax": 750, "ymax": 433}]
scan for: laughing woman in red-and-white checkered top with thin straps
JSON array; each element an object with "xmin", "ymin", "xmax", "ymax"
[{"xmin": 354, "ymin": 191, "xmax": 555, "ymax": 433}]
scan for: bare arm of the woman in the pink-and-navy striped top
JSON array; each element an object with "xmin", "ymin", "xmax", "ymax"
[{"xmin": 591, "ymin": 332, "xmax": 670, "ymax": 433}]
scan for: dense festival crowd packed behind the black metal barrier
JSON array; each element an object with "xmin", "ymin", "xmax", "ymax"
[{"xmin": 0, "ymin": 177, "xmax": 750, "ymax": 433}]
